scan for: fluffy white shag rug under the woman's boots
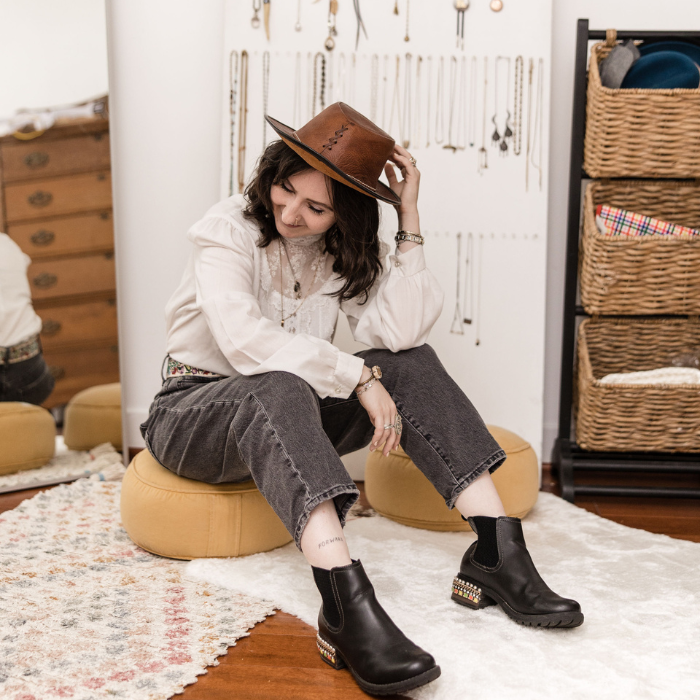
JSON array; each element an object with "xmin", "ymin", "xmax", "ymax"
[{"xmin": 185, "ymin": 493, "xmax": 700, "ymax": 700}]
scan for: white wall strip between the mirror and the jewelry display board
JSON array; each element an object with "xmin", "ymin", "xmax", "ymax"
[{"xmin": 107, "ymin": 0, "xmax": 224, "ymax": 456}]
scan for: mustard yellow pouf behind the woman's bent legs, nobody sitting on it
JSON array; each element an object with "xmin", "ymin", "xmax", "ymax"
[{"xmin": 365, "ymin": 425, "xmax": 540, "ymax": 531}]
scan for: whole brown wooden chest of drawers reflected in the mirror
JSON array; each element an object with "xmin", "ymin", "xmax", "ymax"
[{"xmin": 0, "ymin": 118, "xmax": 119, "ymax": 408}]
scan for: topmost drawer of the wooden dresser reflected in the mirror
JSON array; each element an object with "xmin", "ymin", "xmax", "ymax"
[{"xmin": 0, "ymin": 132, "xmax": 110, "ymax": 182}]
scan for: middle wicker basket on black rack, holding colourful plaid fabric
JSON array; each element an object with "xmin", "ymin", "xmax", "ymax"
[{"xmin": 579, "ymin": 180, "xmax": 700, "ymax": 316}]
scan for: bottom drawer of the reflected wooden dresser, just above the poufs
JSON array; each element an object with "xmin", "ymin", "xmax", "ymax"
[{"xmin": 44, "ymin": 341, "xmax": 119, "ymax": 408}]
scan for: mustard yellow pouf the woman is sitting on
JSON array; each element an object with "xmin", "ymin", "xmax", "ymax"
[{"xmin": 121, "ymin": 450, "xmax": 292, "ymax": 559}]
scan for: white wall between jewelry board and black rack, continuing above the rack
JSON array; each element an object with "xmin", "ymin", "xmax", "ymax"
[{"xmin": 542, "ymin": 0, "xmax": 700, "ymax": 462}]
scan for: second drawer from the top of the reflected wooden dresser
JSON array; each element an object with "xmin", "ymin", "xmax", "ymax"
[{"xmin": 5, "ymin": 171, "xmax": 112, "ymax": 223}]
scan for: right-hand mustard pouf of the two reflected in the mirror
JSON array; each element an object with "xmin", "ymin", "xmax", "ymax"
[{"xmin": 63, "ymin": 382, "xmax": 122, "ymax": 450}]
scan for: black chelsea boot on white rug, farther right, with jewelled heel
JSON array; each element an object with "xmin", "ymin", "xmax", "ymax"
[{"xmin": 452, "ymin": 516, "xmax": 583, "ymax": 628}]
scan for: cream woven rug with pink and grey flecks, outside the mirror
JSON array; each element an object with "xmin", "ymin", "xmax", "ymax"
[{"xmin": 0, "ymin": 475, "xmax": 274, "ymax": 700}]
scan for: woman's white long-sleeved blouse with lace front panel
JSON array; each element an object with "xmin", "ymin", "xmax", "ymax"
[{"xmin": 165, "ymin": 195, "xmax": 443, "ymax": 398}]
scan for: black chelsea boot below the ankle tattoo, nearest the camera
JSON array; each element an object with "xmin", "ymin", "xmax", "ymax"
[{"xmin": 312, "ymin": 560, "xmax": 440, "ymax": 695}]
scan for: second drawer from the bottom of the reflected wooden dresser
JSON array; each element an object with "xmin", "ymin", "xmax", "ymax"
[{"xmin": 37, "ymin": 299, "xmax": 117, "ymax": 351}]
